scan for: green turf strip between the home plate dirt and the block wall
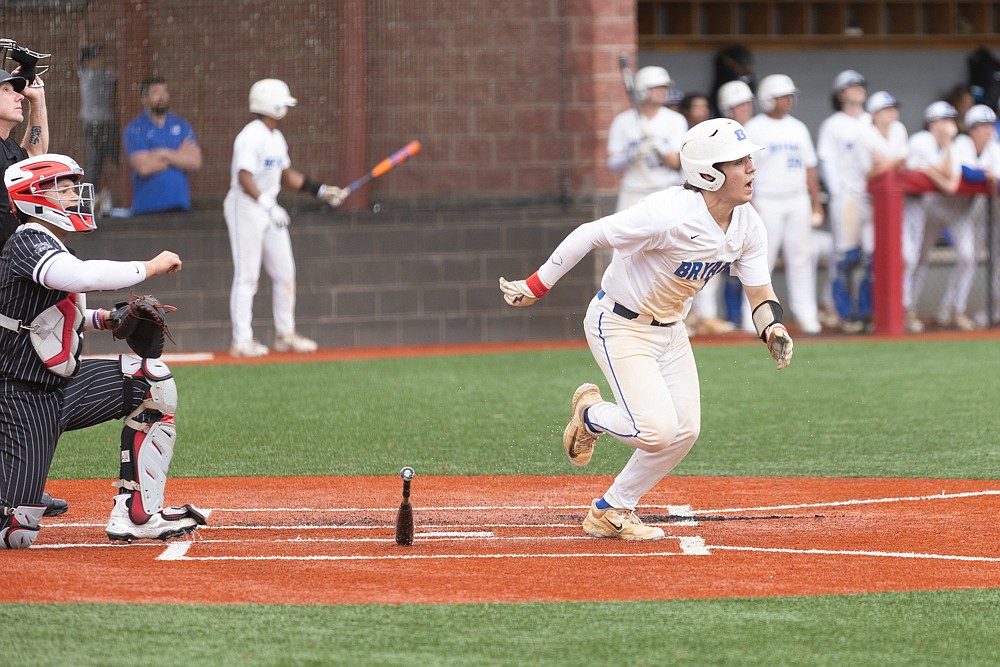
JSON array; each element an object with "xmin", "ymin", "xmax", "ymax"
[{"xmin": 51, "ymin": 341, "xmax": 1000, "ymax": 479}]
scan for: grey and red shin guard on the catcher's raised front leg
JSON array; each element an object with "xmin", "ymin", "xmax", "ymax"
[{"xmin": 115, "ymin": 355, "xmax": 177, "ymax": 524}]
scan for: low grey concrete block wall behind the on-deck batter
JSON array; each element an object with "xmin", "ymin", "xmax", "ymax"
[{"xmin": 70, "ymin": 205, "xmax": 600, "ymax": 353}]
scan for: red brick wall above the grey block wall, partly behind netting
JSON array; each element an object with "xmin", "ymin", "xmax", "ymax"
[{"xmin": 2, "ymin": 0, "xmax": 636, "ymax": 206}]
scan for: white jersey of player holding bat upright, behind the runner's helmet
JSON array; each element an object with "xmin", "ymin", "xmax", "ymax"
[{"xmin": 608, "ymin": 107, "xmax": 688, "ymax": 211}]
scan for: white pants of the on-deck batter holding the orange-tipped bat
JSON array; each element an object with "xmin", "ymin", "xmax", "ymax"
[{"xmin": 224, "ymin": 192, "xmax": 295, "ymax": 343}]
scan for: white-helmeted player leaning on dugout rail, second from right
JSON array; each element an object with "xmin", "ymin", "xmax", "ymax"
[{"xmin": 903, "ymin": 100, "xmax": 961, "ymax": 333}]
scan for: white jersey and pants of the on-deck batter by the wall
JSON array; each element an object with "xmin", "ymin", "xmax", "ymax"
[{"xmin": 224, "ymin": 118, "xmax": 295, "ymax": 343}]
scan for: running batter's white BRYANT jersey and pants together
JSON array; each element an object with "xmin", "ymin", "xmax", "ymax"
[{"xmin": 538, "ymin": 187, "xmax": 770, "ymax": 509}]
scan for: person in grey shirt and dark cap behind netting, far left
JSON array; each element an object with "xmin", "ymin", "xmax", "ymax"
[{"xmin": 77, "ymin": 44, "xmax": 121, "ymax": 215}]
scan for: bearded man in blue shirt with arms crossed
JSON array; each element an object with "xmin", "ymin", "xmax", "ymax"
[{"xmin": 125, "ymin": 77, "xmax": 201, "ymax": 215}]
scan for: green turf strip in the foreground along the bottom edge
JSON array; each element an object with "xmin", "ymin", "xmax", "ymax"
[{"xmin": 0, "ymin": 588, "xmax": 1000, "ymax": 667}]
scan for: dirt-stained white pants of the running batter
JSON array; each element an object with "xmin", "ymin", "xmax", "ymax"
[{"xmin": 584, "ymin": 295, "xmax": 701, "ymax": 509}]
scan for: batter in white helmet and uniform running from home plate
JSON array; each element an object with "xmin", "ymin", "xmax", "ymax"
[{"xmin": 500, "ymin": 118, "xmax": 792, "ymax": 540}]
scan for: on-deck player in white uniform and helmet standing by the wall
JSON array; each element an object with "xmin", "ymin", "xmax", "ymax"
[{"xmin": 224, "ymin": 79, "xmax": 348, "ymax": 357}]
